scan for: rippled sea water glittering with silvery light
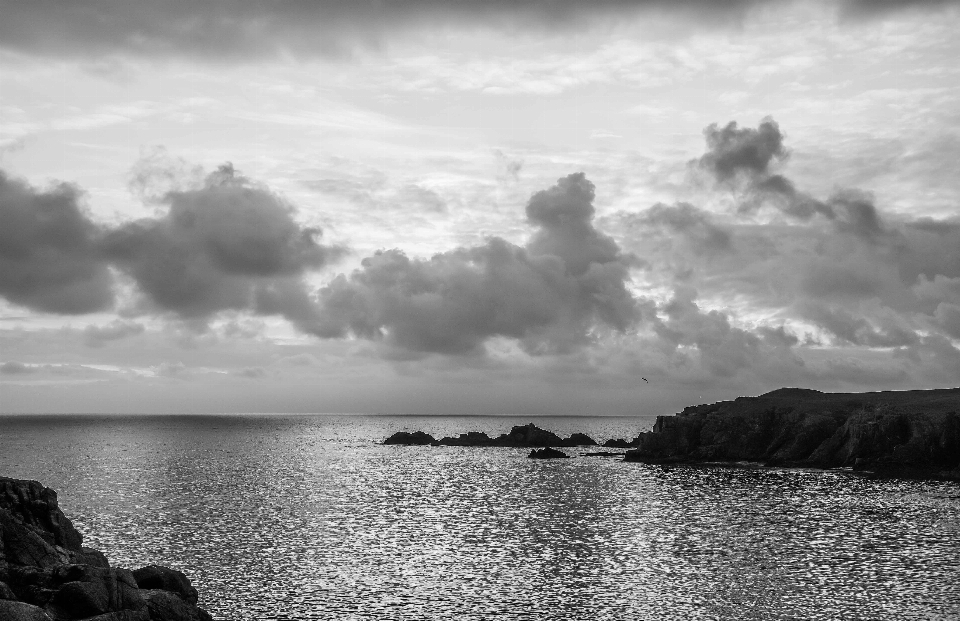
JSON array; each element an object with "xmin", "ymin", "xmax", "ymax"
[{"xmin": 0, "ymin": 415, "xmax": 960, "ymax": 621}]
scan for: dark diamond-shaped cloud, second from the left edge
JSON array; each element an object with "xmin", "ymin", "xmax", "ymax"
[{"xmin": 103, "ymin": 164, "xmax": 342, "ymax": 318}]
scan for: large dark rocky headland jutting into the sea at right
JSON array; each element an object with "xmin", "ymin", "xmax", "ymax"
[{"xmin": 624, "ymin": 388, "xmax": 960, "ymax": 479}]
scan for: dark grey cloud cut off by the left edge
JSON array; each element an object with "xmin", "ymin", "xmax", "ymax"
[{"xmin": 0, "ymin": 171, "xmax": 113, "ymax": 314}]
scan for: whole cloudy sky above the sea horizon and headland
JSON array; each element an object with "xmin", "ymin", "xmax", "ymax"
[{"xmin": 0, "ymin": 0, "xmax": 960, "ymax": 416}]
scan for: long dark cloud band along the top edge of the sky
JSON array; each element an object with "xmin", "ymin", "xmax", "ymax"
[{"xmin": 0, "ymin": 0, "xmax": 755, "ymax": 57}]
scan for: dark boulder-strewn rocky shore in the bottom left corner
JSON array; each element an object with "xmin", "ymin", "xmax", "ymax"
[{"xmin": 0, "ymin": 477, "xmax": 212, "ymax": 621}]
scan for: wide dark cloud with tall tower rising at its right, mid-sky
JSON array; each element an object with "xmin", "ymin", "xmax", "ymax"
[{"xmin": 315, "ymin": 173, "xmax": 639, "ymax": 354}]
